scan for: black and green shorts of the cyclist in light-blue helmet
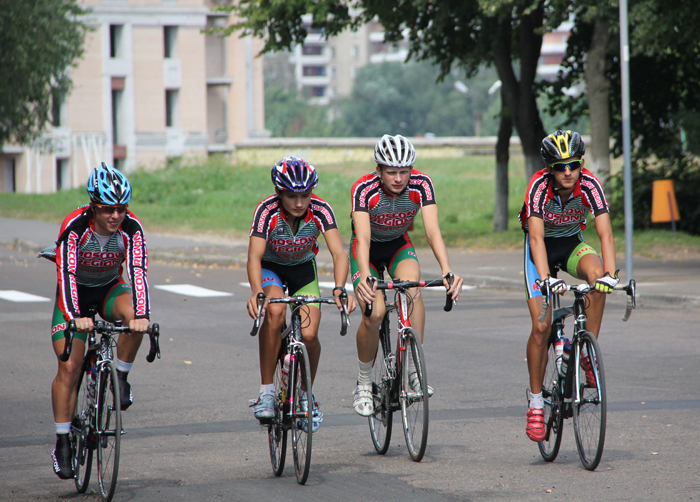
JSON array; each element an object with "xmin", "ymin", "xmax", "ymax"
[{"xmin": 51, "ymin": 277, "xmax": 131, "ymax": 342}]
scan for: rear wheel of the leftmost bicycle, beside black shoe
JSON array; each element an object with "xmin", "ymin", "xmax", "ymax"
[{"xmin": 70, "ymin": 358, "xmax": 94, "ymax": 493}]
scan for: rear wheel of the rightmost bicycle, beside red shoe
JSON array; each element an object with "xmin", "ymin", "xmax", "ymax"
[{"xmin": 537, "ymin": 328, "xmax": 564, "ymax": 462}]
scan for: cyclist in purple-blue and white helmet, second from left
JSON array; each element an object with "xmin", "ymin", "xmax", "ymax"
[{"xmin": 247, "ymin": 157, "xmax": 355, "ymax": 431}]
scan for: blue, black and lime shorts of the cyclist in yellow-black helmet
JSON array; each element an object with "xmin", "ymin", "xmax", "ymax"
[{"xmin": 525, "ymin": 233, "xmax": 598, "ymax": 300}]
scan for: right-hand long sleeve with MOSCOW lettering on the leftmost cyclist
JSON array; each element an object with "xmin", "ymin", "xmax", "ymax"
[{"xmin": 122, "ymin": 212, "xmax": 151, "ymax": 319}]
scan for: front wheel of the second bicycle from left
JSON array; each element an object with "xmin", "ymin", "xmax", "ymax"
[{"xmin": 290, "ymin": 345, "xmax": 314, "ymax": 485}]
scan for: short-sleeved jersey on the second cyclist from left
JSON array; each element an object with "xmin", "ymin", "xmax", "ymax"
[{"xmin": 250, "ymin": 194, "xmax": 338, "ymax": 266}]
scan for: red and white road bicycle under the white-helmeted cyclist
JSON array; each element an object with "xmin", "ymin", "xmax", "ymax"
[{"xmin": 365, "ymin": 266, "xmax": 454, "ymax": 462}]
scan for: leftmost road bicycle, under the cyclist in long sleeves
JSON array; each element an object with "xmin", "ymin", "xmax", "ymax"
[{"xmin": 59, "ymin": 313, "xmax": 160, "ymax": 502}]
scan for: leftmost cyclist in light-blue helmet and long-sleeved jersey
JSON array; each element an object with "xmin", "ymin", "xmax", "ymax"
[{"xmin": 39, "ymin": 162, "xmax": 151, "ymax": 479}]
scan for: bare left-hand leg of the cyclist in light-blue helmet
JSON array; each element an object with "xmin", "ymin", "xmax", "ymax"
[{"xmin": 51, "ymin": 338, "xmax": 85, "ymax": 423}]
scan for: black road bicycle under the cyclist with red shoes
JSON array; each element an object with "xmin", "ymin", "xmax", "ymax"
[{"xmin": 538, "ymin": 280, "xmax": 636, "ymax": 471}]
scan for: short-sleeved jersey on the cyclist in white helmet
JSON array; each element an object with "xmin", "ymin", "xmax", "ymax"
[{"xmin": 351, "ymin": 169, "xmax": 436, "ymax": 242}]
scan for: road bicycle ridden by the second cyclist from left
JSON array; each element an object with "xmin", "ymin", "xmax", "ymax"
[{"xmin": 250, "ymin": 291, "xmax": 349, "ymax": 485}]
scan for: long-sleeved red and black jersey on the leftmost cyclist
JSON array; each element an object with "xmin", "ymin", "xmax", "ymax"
[{"xmin": 55, "ymin": 206, "xmax": 151, "ymax": 321}]
